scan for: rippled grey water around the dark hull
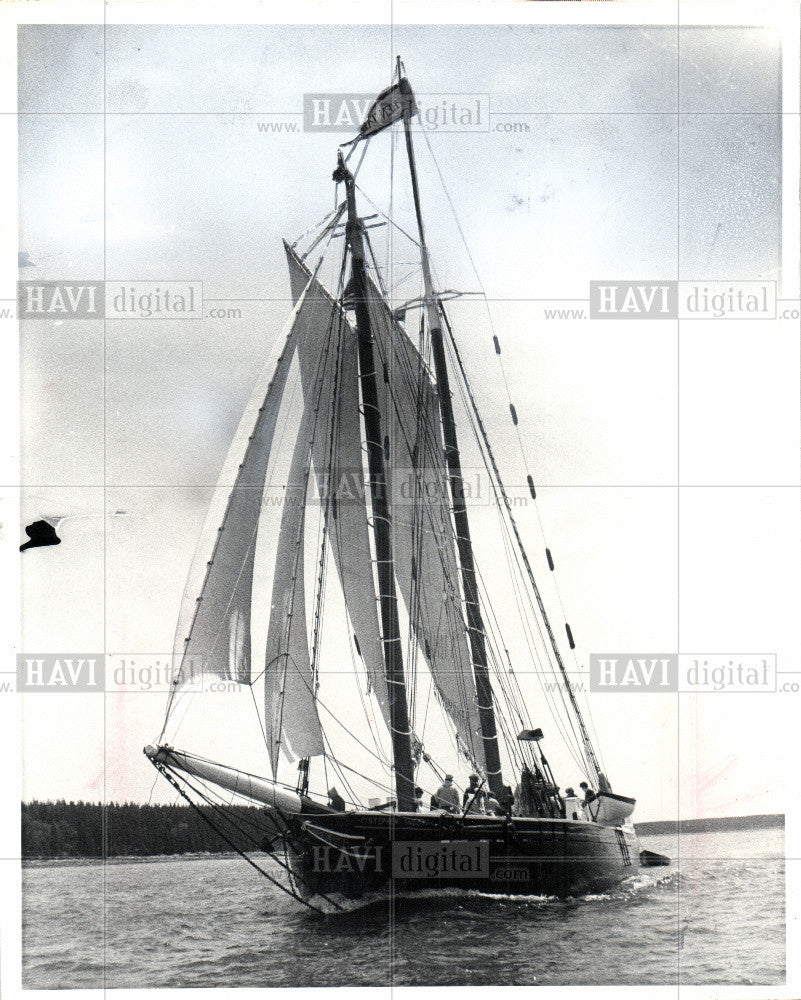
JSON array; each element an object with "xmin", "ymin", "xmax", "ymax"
[{"xmin": 23, "ymin": 830, "xmax": 785, "ymax": 989}]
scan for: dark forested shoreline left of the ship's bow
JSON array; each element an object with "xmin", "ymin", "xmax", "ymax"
[{"xmin": 22, "ymin": 800, "xmax": 261, "ymax": 858}]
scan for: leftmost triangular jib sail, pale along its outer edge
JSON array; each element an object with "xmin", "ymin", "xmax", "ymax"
[{"xmin": 174, "ymin": 295, "xmax": 306, "ymax": 685}]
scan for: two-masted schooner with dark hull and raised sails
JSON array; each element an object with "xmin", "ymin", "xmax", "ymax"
[{"xmin": 145, "ymin": 60, "xmax": 640, "ymax": 909}]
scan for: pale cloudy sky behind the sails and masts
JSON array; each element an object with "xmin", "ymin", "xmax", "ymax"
[{"xmin": 12, "ymin": 26, "xmax": 801, "ymax": 819}]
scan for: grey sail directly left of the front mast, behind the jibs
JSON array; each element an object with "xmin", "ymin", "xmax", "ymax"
[{"xmin": 286, "ymin": 245, "xmax": 389, "ymax": 725}]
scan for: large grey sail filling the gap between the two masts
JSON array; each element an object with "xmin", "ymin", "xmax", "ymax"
[{"xmin": 368, "ymin": 285, "xmax": 483, "ymax": 765}]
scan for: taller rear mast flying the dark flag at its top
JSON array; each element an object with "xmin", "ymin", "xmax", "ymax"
[{"xmin": 398, "ymin": 72, "xmax": 503, "ymax": 801}]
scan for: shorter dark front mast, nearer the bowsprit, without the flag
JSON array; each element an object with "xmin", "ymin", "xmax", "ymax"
[{"xmin": 334, "ymin": 152, "xmax": 415, "ymax": 812}]
